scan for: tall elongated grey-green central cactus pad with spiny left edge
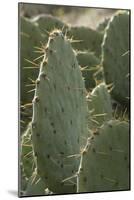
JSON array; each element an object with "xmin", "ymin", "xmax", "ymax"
[{"xmin": 32, "ymin": 31, "xmax": 88, "ymax": 193}]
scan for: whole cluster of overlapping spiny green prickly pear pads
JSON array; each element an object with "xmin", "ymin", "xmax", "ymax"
[{"xmin": 20, "ymin": 8, "xmax": 130, "ymax": 196}]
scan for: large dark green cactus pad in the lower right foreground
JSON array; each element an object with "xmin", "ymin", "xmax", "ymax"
[{"xmin": 77, "ymin": 120, "xmax": 130, "ymax": 192}]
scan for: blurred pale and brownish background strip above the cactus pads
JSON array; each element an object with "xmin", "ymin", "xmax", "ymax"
[{"xmin": 19, "ymin": 3, "xmax": 117, "ymax": 29}]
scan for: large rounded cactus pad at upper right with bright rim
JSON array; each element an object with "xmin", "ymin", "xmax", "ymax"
[{"xmin": 102, "ymin": 11, "xmax": 130, "ymax": 104}]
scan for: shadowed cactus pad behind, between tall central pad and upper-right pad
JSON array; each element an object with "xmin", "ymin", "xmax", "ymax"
[{"xmin": 77, "ymin": 52, "xmax": 100, "ymax": 90}]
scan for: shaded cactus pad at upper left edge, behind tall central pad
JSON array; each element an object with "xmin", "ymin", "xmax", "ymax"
[{"xmin": 20, "ymin": 17, "xmax": 43, "ymax": 103}]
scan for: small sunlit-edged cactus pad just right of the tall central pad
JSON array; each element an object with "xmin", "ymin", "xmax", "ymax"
[{"xmin": 87, "ymin": 82, "xmax": 112, "ymax": 126}]
